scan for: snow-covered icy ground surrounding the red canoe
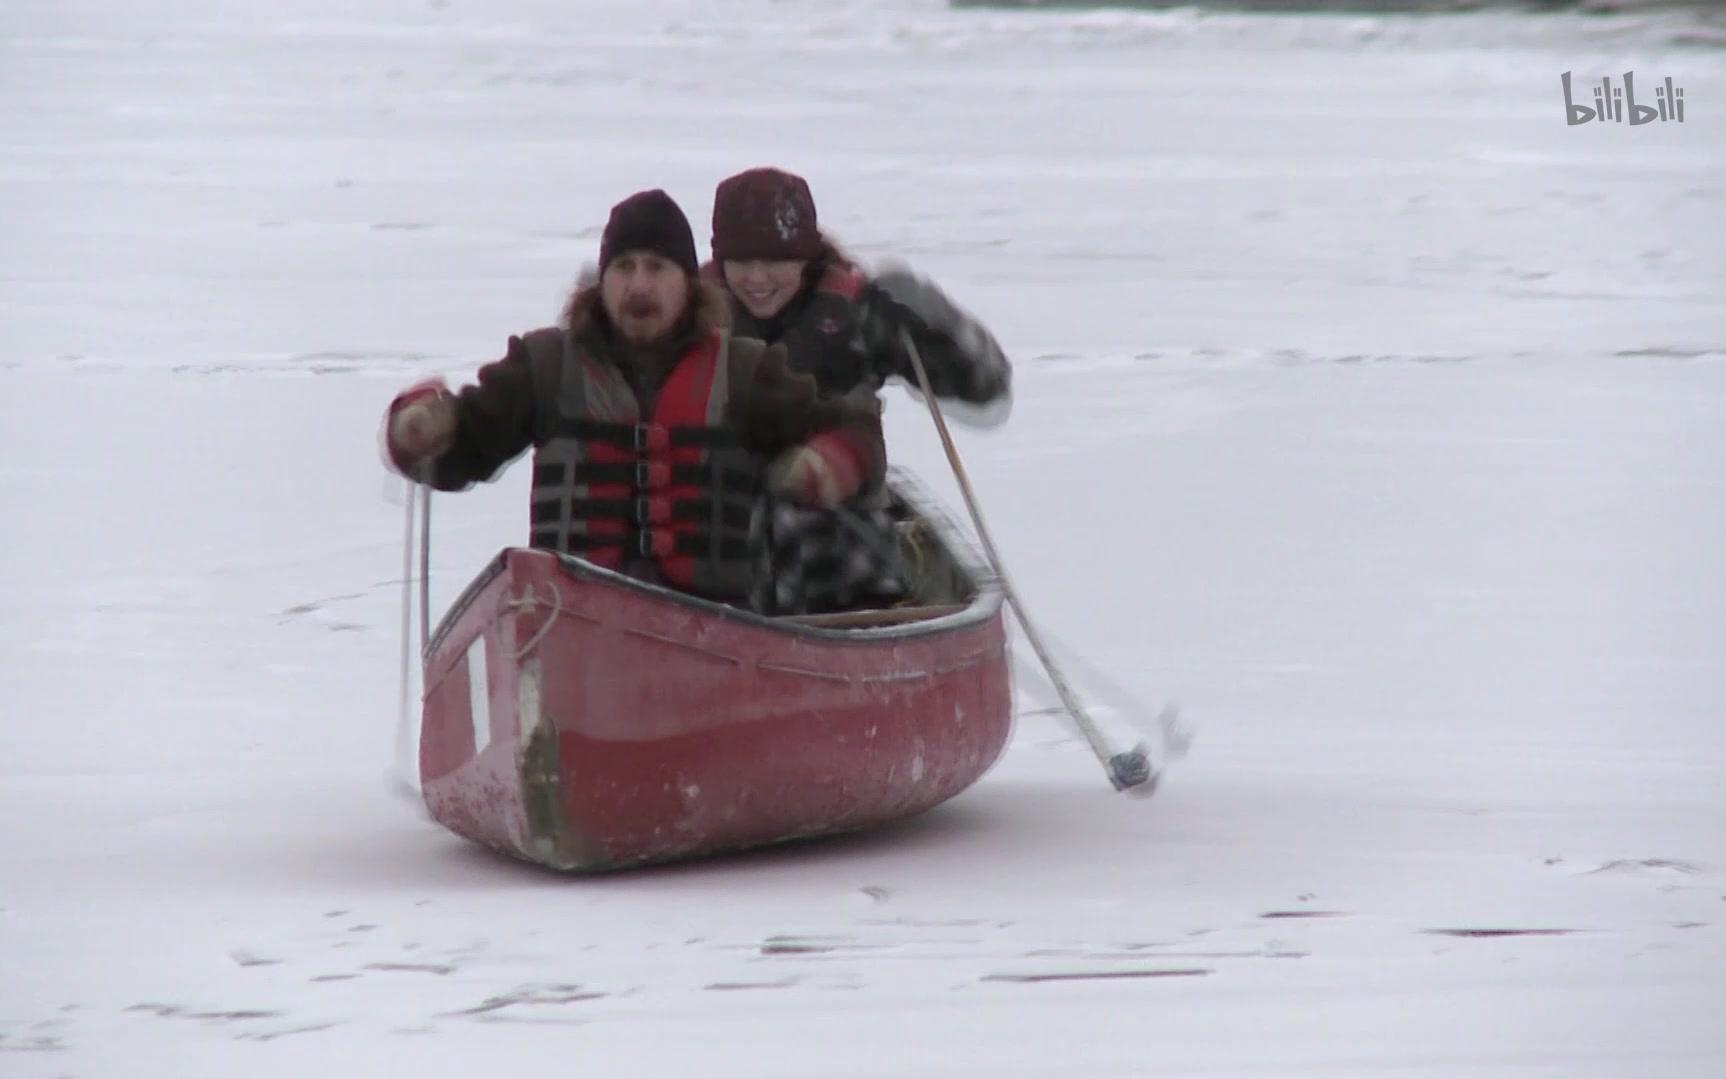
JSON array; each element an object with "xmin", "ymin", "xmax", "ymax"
[{"xmin": 0, "ymin": 0, "xmax": 1726, "ymax": 1079}]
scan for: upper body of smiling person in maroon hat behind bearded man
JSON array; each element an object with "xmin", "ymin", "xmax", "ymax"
[{"xmin": 702, "ymin": 167, "xmax": 1013, "ymax": 425}]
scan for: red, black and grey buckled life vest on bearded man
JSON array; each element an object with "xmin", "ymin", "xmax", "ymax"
[{"xmin": 530, "ymin": 333, "xmax": 759, "ymax": 599}]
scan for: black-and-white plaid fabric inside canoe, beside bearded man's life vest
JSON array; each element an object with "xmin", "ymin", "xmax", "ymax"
[{"xmin": 749, "ymin": 497, "xmax": 910, "ymax": 615}]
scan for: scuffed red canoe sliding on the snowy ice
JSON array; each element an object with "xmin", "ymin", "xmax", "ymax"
[{"xmin": 419, "ymin": 478, "xmax": 1011, "ymax": 872}]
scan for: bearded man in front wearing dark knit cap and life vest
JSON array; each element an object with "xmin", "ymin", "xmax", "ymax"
[{"xmin": 385, "ymin": 190, "xmax": 885, "ymax": 609}]
